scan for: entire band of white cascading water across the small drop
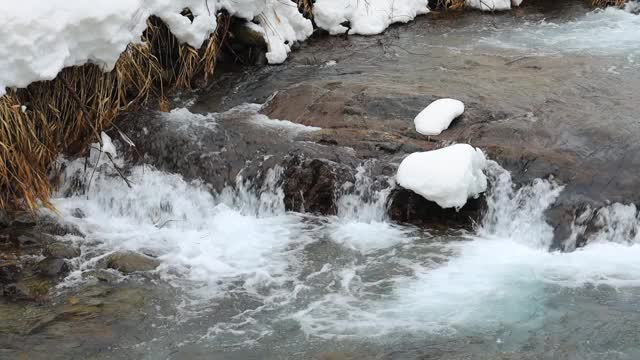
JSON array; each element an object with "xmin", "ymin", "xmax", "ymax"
[{"xmin": 50, "ymin": 134, "xmax": 640, "ymax": 354}]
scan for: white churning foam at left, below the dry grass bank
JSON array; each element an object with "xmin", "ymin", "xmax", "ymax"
[{"xmin": 54, "ymin": 163, "xmax": 304, "ymax": 296}]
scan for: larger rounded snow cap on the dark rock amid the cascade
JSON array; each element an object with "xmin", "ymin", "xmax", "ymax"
[{"xmin": 396, "ymin": 144, "xmax": 487, "ymax": 209}]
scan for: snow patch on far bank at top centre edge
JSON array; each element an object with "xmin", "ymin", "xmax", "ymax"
[{"xmin": 313, "ymin": 0, "xmax": 429, "ymax": 35}]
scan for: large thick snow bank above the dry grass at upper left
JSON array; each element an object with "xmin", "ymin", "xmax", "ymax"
[{"xmin": 0, "ymin": 0, "xmax": 313, "ymax": 96}]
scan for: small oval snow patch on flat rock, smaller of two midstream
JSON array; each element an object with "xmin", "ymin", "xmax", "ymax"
[{"xmin": 413, "ymin": 99, "xmax": 464, "ymax": 135}]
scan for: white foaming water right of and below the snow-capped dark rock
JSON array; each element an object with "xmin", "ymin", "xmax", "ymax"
[{"xmin": 291, "ymin": 164, "xmax": 640, "ymax": 341}]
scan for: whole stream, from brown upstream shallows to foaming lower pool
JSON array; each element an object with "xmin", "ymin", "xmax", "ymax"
[{"xmin": 0, "ymin": 1, "xmax": 640, "ymax": 359}]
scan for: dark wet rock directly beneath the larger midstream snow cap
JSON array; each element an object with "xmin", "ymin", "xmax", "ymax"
[{"xmin": 387, "ymin": 188, "xmax": 486, "ymax": 230}]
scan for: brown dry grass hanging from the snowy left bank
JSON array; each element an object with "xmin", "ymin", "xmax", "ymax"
[{"xmin": 0, "ymin": 14, "xmax": 230, "ymax": 210}]
